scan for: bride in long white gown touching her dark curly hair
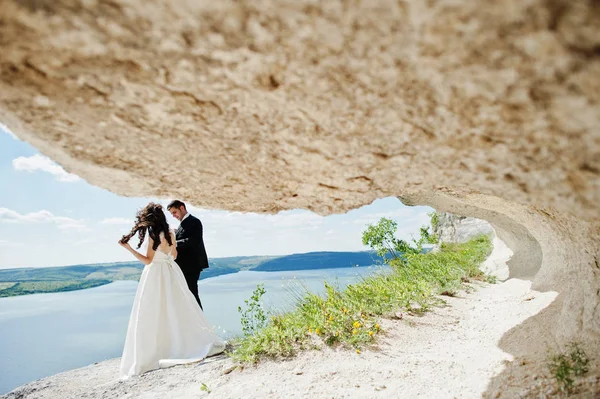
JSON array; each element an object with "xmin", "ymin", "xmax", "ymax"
[{"xmin": 119, "ymin": 203, "xmax": 225, "ymax": 378}]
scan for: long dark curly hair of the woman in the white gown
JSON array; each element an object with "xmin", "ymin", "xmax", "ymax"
[{"xmin": 121, "ymin": 202, "xmax": 173, "ymax": 251}]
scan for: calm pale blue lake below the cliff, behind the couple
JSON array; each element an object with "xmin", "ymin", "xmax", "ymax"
[{"xmin": 0, "ymin": 267, "xmax": 378, "ymax": 394}]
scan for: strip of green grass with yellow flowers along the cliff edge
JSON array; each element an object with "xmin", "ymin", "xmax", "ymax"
[{"xmin": 231, "ymin": 236, "xmax": 491, "ymax": 363}]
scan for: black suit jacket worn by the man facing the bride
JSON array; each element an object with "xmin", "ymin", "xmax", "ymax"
[{"xmin": 175, "ymin": 215, "xmax": 208, "ymax": 274}]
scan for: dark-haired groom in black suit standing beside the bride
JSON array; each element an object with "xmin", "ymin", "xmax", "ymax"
[{"xmin": 167, "ymin": 200, "xmax": 208, "ymax": 309}]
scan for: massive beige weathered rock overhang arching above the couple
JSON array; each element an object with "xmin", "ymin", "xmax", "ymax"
[{"xmin": 0, "ymin": 0, "xmax": 600, "ymax": 394}]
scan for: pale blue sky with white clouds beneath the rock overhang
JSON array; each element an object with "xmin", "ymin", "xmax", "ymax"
[{"xmin": 0, "ymin": 124, "xmax": 432, "ymax": 269}]
